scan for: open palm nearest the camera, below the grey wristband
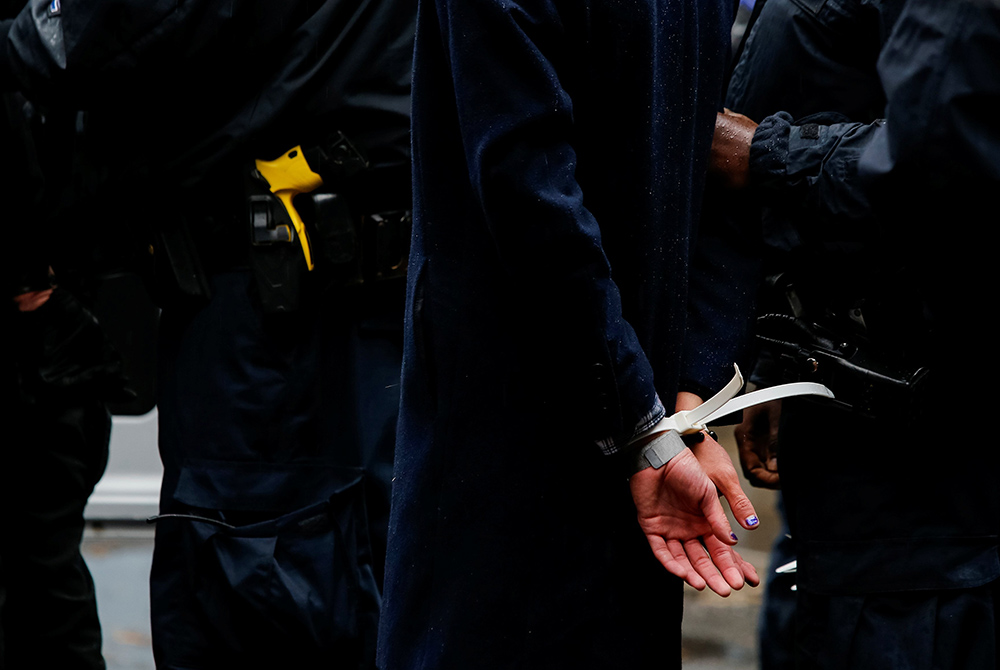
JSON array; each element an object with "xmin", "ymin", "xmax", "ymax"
[{"xmin": 629, "ymin": 449, "xmax": 760, "ymax": 597}]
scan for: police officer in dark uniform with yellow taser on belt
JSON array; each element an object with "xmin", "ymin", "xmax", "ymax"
[{"xmin": 0, "ymin": 0, "xmax": 415, "ymax": 668}]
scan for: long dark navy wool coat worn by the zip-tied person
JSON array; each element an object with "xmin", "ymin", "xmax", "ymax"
[{"xmin": 380, "ymin": 0, "xmax": 732, "ymax": 670}]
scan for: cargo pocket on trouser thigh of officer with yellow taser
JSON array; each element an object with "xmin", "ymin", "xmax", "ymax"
[{"xmin": 155, "ymin": 461, "xmax": 380, "ymax": 668}]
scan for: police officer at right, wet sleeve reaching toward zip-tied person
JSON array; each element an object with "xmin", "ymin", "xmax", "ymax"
[{"xmin": 716, "ymin": 0, "xmax": 1000, "ymax": 668}]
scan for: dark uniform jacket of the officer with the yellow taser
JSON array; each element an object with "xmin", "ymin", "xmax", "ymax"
[{"xmin": 0, "ymin": 0, "xmax": 413, "ymax": 193}]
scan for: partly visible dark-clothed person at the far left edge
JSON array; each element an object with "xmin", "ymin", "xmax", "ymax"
[{"xmin": 0, "ymin": 89, "xmax": 125, "ymax": 670}]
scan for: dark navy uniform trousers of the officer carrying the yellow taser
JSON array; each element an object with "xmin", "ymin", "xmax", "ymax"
[{"xmin": 151, "ymin": 271, "xmax": 403, "ymax": 670}]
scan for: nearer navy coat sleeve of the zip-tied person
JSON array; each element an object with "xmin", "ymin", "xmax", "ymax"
[{"xmin": 436, "ymin": 0, "xmax": 664, "ymax": 453}]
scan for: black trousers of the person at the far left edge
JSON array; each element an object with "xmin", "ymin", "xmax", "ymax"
[{"xmin": 0, "ymin": 400, "xmax": 110, "ymax": 670}]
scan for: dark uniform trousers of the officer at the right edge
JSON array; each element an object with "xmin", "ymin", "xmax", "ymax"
[{"xmin": 779, "ymin": 400, "xmax": 1000, "ymax": 670}]
